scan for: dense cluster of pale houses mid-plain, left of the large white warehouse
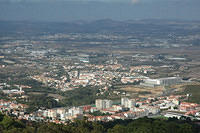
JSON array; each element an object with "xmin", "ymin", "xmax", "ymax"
[{"xmin": 31, "ymin": 64, "xmax": 153, "ymax": 91}]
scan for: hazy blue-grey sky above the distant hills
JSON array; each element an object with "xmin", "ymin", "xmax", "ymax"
[{"xmin": 0, "ymin": 0, "xmax": 200, "ymax": 22}]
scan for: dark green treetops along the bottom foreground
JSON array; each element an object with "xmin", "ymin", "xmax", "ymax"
[{"xmin": 0, "ymin": 114, "xmax": 200, "ymax": 133}]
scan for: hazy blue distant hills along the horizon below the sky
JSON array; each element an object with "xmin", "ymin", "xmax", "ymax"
[{"xmin": 0, "ymin": 19, "xmax": 200, "ymax": 34}]
